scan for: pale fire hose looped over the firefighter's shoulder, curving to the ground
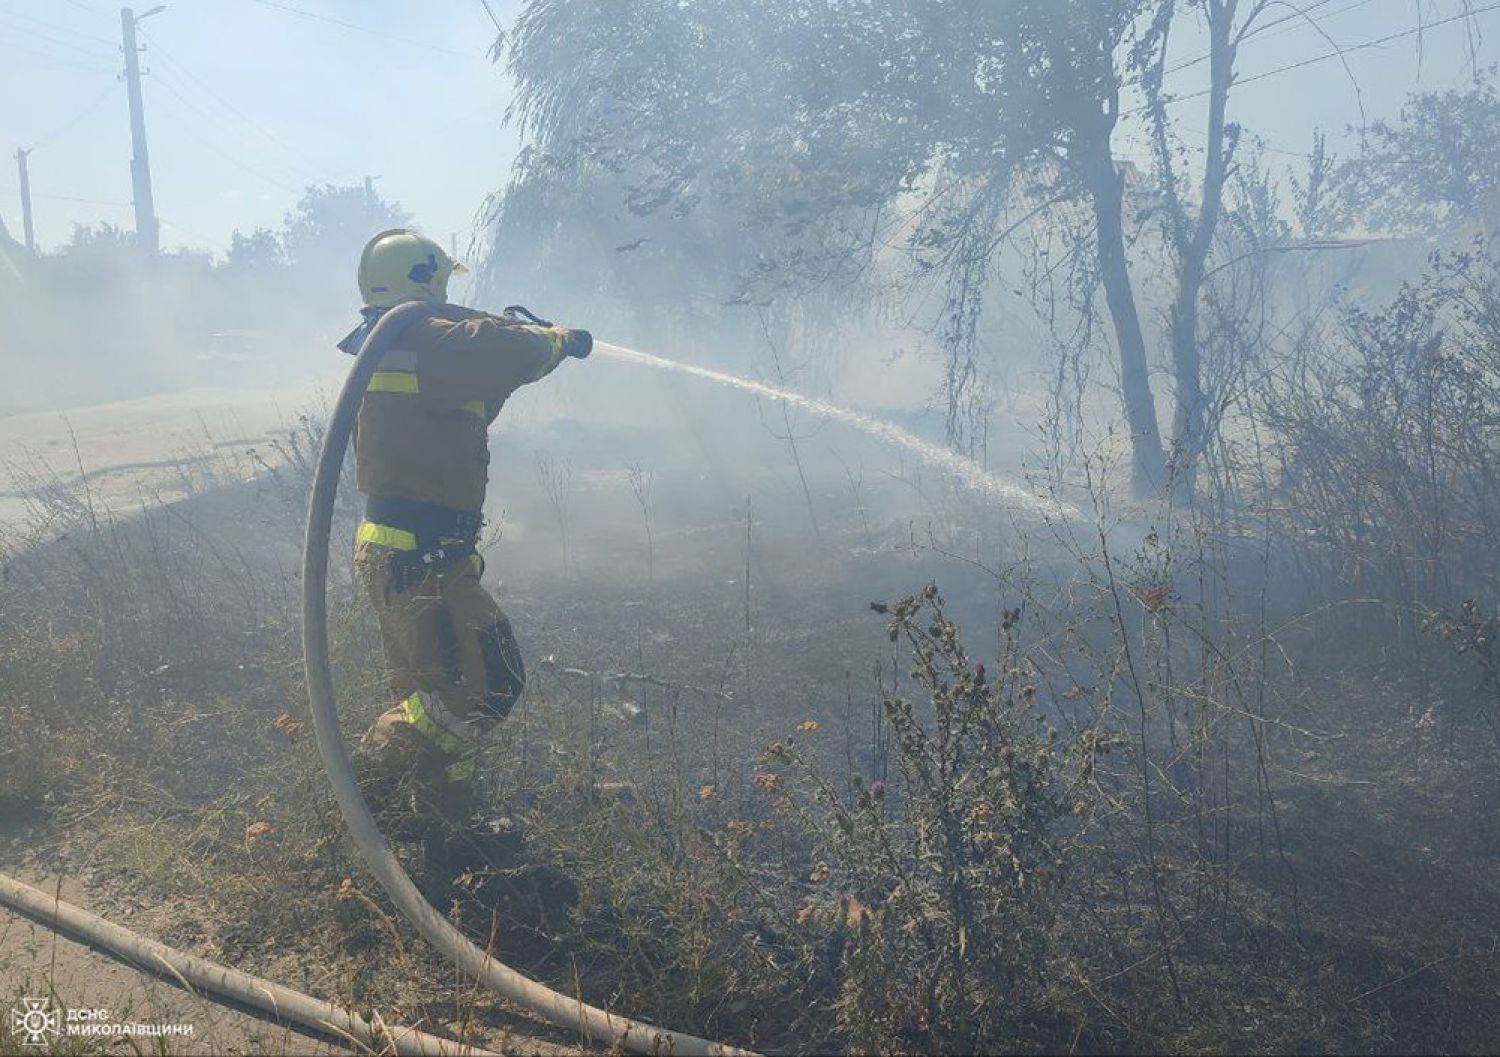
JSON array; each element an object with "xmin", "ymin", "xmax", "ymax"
[{"xmin": 302, "ymin": 301, "xmax": 749, "ymax": 1057}]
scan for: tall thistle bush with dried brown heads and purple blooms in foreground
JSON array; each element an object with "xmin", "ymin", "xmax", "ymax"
[{"xmin": 785, "ymin": 586, "xmax": 1071, "ymax": 1054}]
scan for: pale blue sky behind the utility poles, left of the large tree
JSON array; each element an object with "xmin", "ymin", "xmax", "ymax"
[{"xmin": 0, "ymin": 0, "xmax": 519, "ymax": 250}]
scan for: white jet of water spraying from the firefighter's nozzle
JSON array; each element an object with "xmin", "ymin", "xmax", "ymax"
[{"xmin": 594, "ymin": 342, "xmax": 1082, "ymax": 520}]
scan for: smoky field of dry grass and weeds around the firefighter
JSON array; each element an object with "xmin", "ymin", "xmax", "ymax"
[{"xmin": 0, "ymin": 380, "xmax": 1500, "ymax": 1053}]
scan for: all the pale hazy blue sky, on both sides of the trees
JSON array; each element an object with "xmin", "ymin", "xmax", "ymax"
[{"xmin": 0, "ymin": 0, "xmax": 1500, "ymax": 250}]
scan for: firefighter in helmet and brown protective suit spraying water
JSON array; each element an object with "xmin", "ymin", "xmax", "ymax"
[{"xmin": 339, "ymin": 229, "xmax": 593, "ymax": 870}]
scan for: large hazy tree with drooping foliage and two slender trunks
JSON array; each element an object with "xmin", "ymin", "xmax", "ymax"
[{"xmin": 500, "ymin": 0, "xmax": 1296, "ymax": 492}]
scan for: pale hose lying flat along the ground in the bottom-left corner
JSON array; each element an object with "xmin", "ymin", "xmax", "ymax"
[{"xmin": 0, "ymin": 874, "xmax": 507, "ymax": 1057}]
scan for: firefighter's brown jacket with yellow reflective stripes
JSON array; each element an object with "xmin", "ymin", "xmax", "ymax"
[{"xmin": 350, "ymin": 304, "xmax": 567, "ymax": 511}]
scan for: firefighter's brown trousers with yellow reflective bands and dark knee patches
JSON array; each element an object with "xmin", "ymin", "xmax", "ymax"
[{"xmin": 354, "ymin": 522, "xmax": 525, "ymax": 829}]
